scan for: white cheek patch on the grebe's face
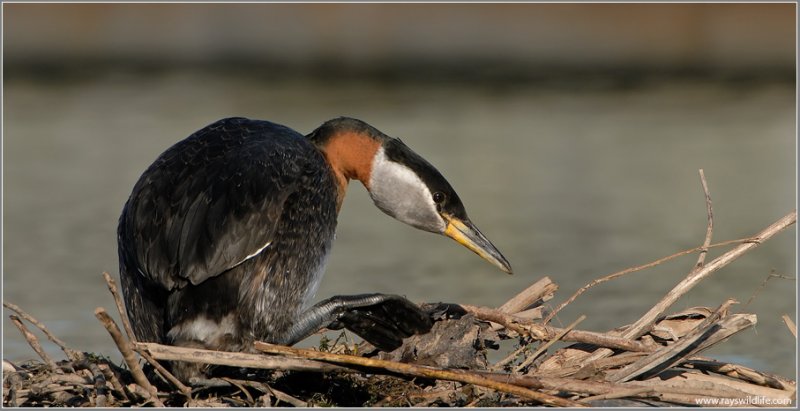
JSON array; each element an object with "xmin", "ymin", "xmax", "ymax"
[{"xmin": 369, "ymin": 147, "xmax": 445, "ymax": 233}]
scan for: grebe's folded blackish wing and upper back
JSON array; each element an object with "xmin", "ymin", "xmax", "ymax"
[{"xmin": 120, "ymin": 118, "xmax": 324, "ymax": 289}]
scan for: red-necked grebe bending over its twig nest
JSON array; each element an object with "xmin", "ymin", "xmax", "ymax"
[{"xmin": 118, "ymin": 118, "xmax": 511, "ymax": 379}]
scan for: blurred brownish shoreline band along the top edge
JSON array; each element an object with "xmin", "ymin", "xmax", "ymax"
[{"xmin": 3, "ymin": 2, "xmax": 797, "ymax": 80}]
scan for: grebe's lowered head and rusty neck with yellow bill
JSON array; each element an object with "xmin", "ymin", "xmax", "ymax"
[{"xmin": 309, "ymin": 117, "xmax": 511, "ymax": 274}]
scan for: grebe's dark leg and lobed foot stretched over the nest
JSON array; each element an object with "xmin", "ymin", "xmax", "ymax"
[{"xmin": 282, "ymin": 294, "xmax": 433, "ymax": 351}]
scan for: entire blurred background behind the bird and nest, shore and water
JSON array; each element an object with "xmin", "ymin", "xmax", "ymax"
[{"xmin": 3, "ymin": 4, "xmax": 797, "ymax": 378}]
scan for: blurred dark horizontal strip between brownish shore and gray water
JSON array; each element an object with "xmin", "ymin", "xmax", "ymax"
[{"xmin": 4, "ymin": 59, "xmax": 796, "ymax": 90}]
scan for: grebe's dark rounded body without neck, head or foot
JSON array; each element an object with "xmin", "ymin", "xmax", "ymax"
[{"xmin": 118, "ymin": 118, "xmax": 336, "ymax": 348}]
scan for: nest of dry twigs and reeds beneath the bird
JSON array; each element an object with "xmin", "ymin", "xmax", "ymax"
[{"xmin": 3, "ymin": 172, "xmax": 797, "ymax": 407}]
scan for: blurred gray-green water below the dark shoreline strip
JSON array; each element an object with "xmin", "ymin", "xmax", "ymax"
[{"xmin": 3, "ymin": 71, "xmax": 796, "ymax": 377}]
